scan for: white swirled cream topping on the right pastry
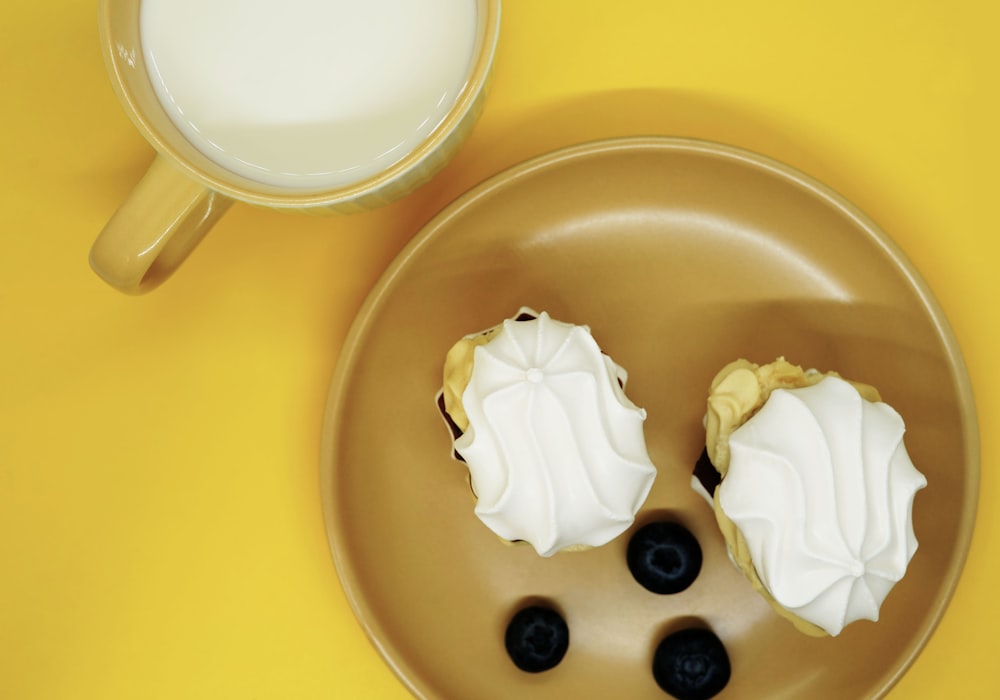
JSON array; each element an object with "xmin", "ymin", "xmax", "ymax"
[{"xmin": 719, "ymin": 377, "xmax": 927, "ymax": 635}]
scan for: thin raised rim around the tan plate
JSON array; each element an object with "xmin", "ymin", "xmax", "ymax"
[{"xmin": 319, "ymin": 136, "xmax": 982, "ymax": 699}]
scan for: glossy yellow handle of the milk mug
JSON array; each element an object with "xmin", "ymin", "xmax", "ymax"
[{"xmin": 90, "ymin": 155, "xmax": 233, "ymax": 294}]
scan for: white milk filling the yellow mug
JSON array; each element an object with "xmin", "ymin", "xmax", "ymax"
[{"xmin": 140, "ymin": 0, "xmax": 476, "ymax": 190}]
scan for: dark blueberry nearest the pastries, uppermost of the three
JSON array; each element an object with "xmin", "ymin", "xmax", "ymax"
[{"xmin": 626, "ymin": 521, "xmax": 701, "ymax": 593}]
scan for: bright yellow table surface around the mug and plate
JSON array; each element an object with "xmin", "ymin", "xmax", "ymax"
[{"xmin": 0, "ymin": 0, "xmax": 1000, "ymax": 700}]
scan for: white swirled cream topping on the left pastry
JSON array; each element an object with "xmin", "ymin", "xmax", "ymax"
[{"xmin": 455, "ymin": 312, "xmax": 656, "ymax": 556}]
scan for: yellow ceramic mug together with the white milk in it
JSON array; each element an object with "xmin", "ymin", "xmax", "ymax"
[{"xmin": 90, "ymin": 0, "xmax": 500, "ymax": 293}]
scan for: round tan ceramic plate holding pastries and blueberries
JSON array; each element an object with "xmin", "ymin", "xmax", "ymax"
[{"xmin": 322, "ymin": 139, "xmax": 979, "ymax": 700}]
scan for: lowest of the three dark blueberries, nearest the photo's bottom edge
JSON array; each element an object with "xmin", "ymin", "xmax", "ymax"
[{"xmin": 653, "ymin": 627, "xmax": 731, "ymax": 700}]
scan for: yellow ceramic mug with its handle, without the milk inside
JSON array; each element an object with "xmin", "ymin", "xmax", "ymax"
[{"xmin": 90, "ymin": 0, "xmax": 501, "ymax": 294}]
